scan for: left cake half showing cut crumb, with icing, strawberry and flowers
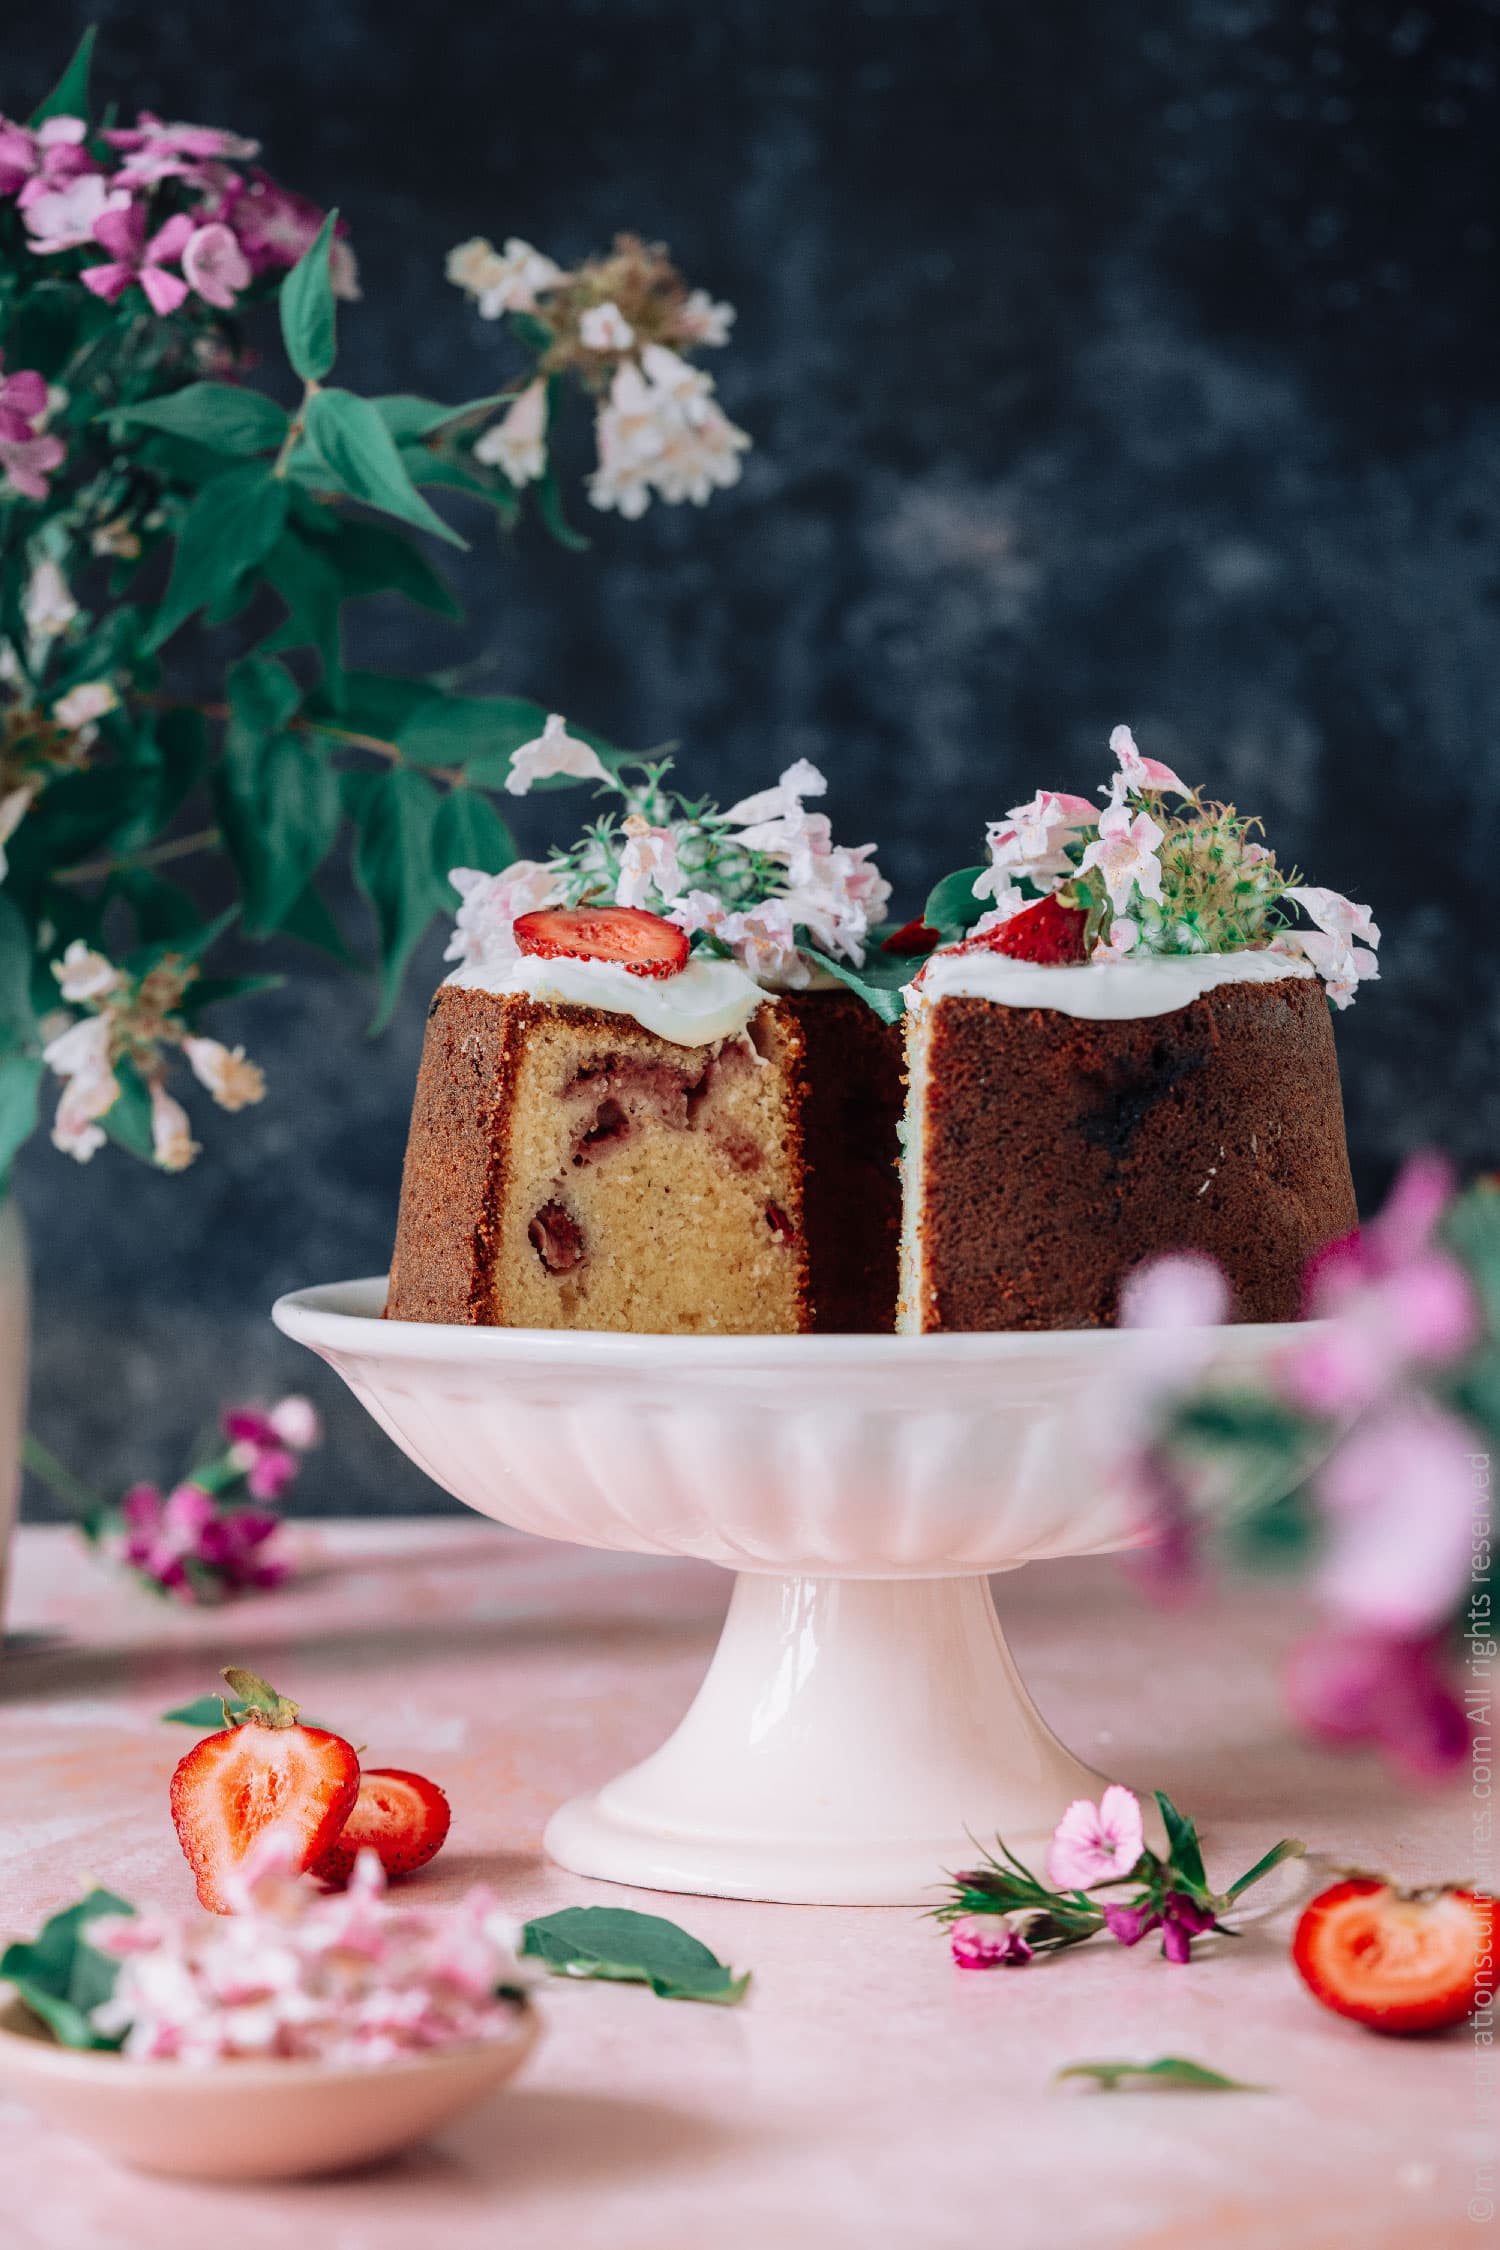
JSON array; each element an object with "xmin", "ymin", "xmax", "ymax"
[{"xmin": 387, "ymin": 738, "xmax": 902, "ymax": 1334}]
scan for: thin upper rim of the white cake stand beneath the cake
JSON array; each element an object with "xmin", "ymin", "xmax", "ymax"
[{"xmin": 270, "ymin": 1274, "xmax": 1325, "ymax": 1373}]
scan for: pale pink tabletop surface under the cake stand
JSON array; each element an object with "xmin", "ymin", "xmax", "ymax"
[{"xmin": 0, "ymin": 1521, "xmax": 1500, "ymax": 2250}]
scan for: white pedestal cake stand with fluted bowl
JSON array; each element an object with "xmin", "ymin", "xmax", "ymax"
[{"xmin": 274, "ymin": 1280, "xmax": 1289, "ymax": 1906}]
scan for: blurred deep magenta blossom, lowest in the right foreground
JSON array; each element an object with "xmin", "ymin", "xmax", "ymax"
[{"xmin": 1286, "ymin": 1631, "xmax": 1469, "ymax": 1780}]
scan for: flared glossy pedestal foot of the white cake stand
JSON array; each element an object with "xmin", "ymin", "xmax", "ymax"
[{"xmin": 546, "ymin": 1573, "xmax": 1102, "ymax": 1906}]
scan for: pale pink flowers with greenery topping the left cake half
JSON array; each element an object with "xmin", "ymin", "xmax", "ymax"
[{"xmin": 448, "ymin": 742, "xmax": 891, "ymax": 990}]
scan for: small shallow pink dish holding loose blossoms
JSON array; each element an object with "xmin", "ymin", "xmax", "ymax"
[{"xmin": 0, "ymin": 2000, "xmax": 542, "ymax": 2183}]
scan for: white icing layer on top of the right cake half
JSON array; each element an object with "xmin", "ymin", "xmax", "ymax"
[{"xmin": 904, "ymin": 945, "xmax": 1316, "ymax": 1024}]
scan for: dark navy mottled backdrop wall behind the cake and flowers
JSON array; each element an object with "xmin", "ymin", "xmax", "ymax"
[{"xmin": 11, "ymin": 0, "xmax": 1500, "ymax": 1510}]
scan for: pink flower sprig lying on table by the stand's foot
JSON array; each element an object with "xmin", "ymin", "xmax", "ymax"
[{"xmin": 936, "ymin": 1782, "xmax": 1304, "ymax": 1969}]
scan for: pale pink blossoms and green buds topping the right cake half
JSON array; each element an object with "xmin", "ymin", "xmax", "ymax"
[{"xmin": 924, "ymin": 727, "xmax": 1381, "ymax": 1008}]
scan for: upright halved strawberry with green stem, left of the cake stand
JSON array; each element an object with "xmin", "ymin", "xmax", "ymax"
[{"xmin": 171, "ymin": 1665, "xmax": 360, "ymax": 1915}]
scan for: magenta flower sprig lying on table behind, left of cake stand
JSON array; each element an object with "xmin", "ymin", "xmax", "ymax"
[{"xmin": 25, "ymin": 1397, "xmax": 322, "ymax": 1604}]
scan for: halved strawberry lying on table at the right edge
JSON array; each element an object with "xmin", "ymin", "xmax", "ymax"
[{"xmin": 1291, "ymin": 1874, "xmax": 1496, "ymax": 2032}]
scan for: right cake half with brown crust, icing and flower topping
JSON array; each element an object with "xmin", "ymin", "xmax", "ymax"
[{"xmin": 900, "ymin": 729, "xmax": 1379, "ymax": 1332}]
